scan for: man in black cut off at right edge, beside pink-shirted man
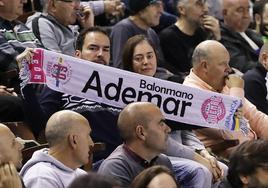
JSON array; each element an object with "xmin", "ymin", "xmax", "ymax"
[{"xmin": 243, "ymin": 43, "xmax": 268, "ymax": 114}]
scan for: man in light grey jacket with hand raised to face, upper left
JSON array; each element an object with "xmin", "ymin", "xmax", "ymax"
[{"xmin": 27, "ymin": 0, "xmax": 94, "ymax": 56}]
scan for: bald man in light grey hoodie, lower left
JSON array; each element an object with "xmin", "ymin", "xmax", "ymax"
[{"xmin": 20, "ymin": 110, "xmax": 93, "ymax": 188}]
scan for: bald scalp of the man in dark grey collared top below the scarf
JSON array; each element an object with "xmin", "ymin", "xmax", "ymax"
[{"xmin": 117, "ymin": 102, "xmax": 159, "ymax": 141}]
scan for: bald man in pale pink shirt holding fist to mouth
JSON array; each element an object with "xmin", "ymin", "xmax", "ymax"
[{"xmin": 183, "ymin": 40, "xmax": 268, "ymax": 157}]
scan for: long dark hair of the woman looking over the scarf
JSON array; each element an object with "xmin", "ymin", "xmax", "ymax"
[{"xmin": 122, "ymin": 35, "xmax": 157, "ymax": 72}]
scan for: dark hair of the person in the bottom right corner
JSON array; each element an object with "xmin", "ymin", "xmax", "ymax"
[{"xmin": 227, "ymin": 140, "xmax": 268, "ymax": 188}]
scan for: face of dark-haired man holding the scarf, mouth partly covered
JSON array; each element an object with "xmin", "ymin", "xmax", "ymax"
[{"xmin": 76, "ymin": 32, "xmax": 110, "ymax": 65}]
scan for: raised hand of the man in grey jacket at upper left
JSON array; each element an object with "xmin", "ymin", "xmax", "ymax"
[{"xmin": 77, "ymin": 6, "xmax": 94, "ymax": 28}]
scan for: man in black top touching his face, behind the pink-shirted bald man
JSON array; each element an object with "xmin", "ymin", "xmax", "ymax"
[{"xmin": 159, "ymin": 0, "xmax": 221, "ymax": 75}]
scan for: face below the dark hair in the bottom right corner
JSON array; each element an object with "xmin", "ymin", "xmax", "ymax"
[{"xmin": 245, "ymin": 168, "xmax": 268, "ymax": 188}]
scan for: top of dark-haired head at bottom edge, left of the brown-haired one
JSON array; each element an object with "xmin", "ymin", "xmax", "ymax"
[{"xmin": 68, "ymin": 172, "xmax": 119, "ymax": 188}]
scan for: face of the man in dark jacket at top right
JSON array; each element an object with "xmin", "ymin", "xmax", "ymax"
[{"xmin": 223, "ymin": 0, "xmax": 250, "ymax": 32}]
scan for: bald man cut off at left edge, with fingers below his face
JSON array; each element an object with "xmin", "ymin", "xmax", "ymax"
[{"xmin": 0, "ymin": 123, "xmax": 23, "ymax": 188}]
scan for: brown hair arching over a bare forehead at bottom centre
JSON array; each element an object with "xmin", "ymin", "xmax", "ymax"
[{"xmin": 130, "ymin": 165, "xmax": 179, "ymax": 188}]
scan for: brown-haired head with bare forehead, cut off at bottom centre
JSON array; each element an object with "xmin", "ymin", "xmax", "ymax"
[{"xmin": 130, "ymin": 165, "xmax": 179, "ymax": 188}]
